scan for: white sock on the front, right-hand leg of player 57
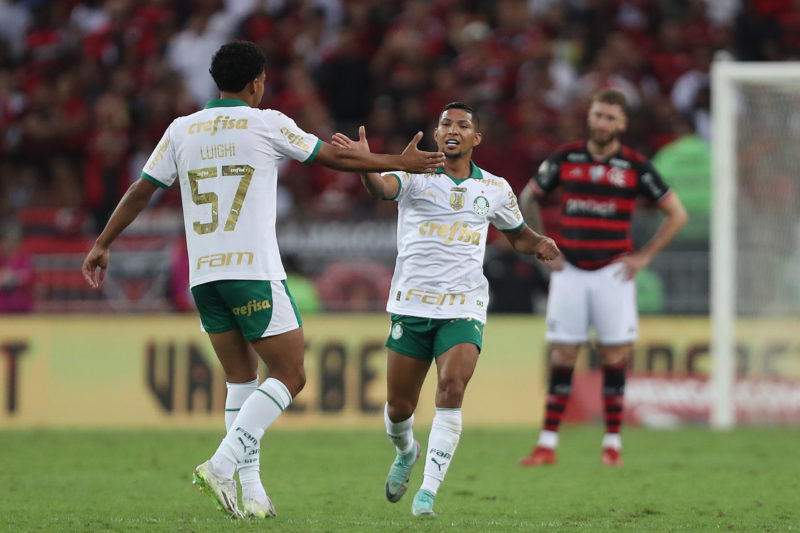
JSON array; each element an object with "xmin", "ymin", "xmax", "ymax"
[{"xmin": 212, "ymin": 378, "xmax": 292, "ymax": 476}]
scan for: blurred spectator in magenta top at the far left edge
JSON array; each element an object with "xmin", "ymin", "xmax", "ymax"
[{"xmin": 0, "ymin": 220, "xmax": 35, "ymax": 313}]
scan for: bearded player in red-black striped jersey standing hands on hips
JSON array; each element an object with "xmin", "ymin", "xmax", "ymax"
[{"xmin": 520, "ymin": 89, "xmax": 688, "ymax": 466}]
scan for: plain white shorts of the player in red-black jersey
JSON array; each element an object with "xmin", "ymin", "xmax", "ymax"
[{"xmin": 545, "ymin": 262, "xmax": 639, "ymax": 346}]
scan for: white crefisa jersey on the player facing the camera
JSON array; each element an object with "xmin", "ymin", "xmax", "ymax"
[{"xmin": 386, "ymin": 162, "xmax": 525, "ymax": 322}]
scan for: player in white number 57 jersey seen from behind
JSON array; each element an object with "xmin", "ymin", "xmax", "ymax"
[{"xmin": 82, "ymin": 41, "xmax": 444, "ymax": 518}]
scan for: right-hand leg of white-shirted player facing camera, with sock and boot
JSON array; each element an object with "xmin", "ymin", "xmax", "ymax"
[{"xmin": 411, "ymin": 343, "xmax": 479, "ymax": 516}]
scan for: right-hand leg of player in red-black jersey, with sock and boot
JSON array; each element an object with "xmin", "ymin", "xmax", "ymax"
[{"xmin": 600, "ymin": 343, "xmax": 633, "ymax": 466}]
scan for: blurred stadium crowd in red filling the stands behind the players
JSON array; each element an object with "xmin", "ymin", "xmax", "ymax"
[{"xmin": 0, "ymin": 0, "xmax": 800, "ymax": 312}]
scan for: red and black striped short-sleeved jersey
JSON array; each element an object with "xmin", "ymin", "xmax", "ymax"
[{"xmin": 529, "ymin": 141, "xmax": 671, "ymax": 270}]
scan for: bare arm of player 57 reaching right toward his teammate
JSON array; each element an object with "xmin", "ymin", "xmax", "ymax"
[{"xmin": 314, "ymin": 132, "xmax": 444, "ymax": 172}]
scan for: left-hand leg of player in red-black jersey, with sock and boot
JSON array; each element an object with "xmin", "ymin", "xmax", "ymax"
[{"xmin": 519, "ymin": 343, "xmax": 581, "ymax": 466}]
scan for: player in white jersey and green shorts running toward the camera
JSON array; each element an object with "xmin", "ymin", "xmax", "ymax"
[{"xmin": 333, "ymin": 102, "xmax": 558, "ymax": 516}]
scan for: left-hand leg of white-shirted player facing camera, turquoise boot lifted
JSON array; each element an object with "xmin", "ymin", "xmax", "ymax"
[{"xmin": 384, "ymin": 349, "xmax": 431, "ymax": 502}]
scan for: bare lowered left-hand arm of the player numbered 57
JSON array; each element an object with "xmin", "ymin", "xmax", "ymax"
[{"xmin": 81, "ymin": 178, "xmax": 158, "ymax": 289}]
